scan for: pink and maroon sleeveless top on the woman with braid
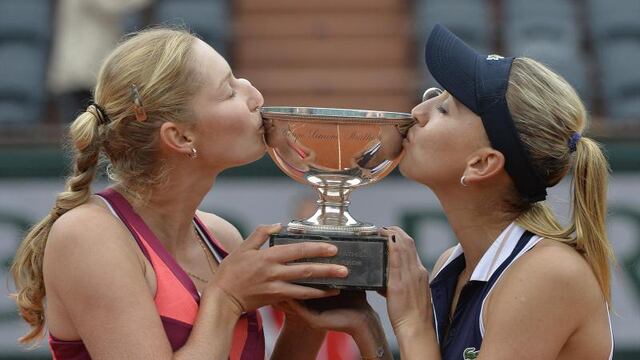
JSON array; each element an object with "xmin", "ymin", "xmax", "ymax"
[{"xmin": 49, "ymin": 189, "xmax": 265, "ymax": 360}]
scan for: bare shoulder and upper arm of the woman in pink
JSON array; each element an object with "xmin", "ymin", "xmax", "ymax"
[{"xmin": 44, "ymin": 200, "xmax": 171, "ymax": 358}]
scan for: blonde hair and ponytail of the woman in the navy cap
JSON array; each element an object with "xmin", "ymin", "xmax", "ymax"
[{"xmin": 507, "ymin": 58, "xmax": 614, "ymax": 302}]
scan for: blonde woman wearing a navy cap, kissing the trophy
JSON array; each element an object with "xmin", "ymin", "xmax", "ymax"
[{"xmin": 387, "ymin": 25, "xmax": 613, "ymax": 360}]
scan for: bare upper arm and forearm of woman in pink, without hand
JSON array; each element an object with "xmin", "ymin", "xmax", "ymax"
[{"xmin": 44, "ymin": 208, "xmax": 238, "ymax": 359}]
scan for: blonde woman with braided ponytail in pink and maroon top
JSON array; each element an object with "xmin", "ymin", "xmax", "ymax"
[{"xmin": 12, "ymin": 29, "xmax": 384, "ymax": 360}]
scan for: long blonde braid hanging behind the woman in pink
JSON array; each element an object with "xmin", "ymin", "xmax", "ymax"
[{"xmin": 11, "ymin": 107, "xmax": 100, "ymax": 344}]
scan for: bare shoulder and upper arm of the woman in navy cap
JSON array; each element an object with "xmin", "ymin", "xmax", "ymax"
[{"xmin": 479, "ymin": 240, "xmax": 592, "ymax": 360}]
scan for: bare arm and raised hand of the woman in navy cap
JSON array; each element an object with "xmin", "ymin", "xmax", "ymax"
[{"xmin": 380, "ymin": 228, "xmax": 603, "ymax": 360}]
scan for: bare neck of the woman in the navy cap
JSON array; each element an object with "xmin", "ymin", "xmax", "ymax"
[{"xmin": 436, "ymin": 194, "xmax": 515, "ymax": 274}]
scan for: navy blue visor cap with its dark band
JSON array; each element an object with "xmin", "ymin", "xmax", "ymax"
[{"xmin": 425, "ymin": 24, "xmax": 547, "ymax": 203}]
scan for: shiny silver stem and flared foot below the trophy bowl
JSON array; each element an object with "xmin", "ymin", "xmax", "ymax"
[{"xmin": 287, "ymin": 187, "xmax": 378, "ymax": 235}]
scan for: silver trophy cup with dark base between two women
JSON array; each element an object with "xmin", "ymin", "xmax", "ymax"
[{"xmin": 261, "ymin": 107, "xmax": 415, "ymax": 290}]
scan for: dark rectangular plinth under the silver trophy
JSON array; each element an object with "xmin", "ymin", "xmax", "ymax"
[{"xmin": 269, "ymin": 231, "xmax": 387, "ymax": 290}]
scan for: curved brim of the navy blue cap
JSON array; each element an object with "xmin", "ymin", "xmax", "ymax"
[{"xmin": 425, "ymin": 24, "xmax": 480, "ymax": 113}]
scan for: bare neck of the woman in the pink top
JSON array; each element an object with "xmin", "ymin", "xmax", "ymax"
[{"xmin": 116, "ymin": 164, "xmax": 217, "ymax": 253}]
